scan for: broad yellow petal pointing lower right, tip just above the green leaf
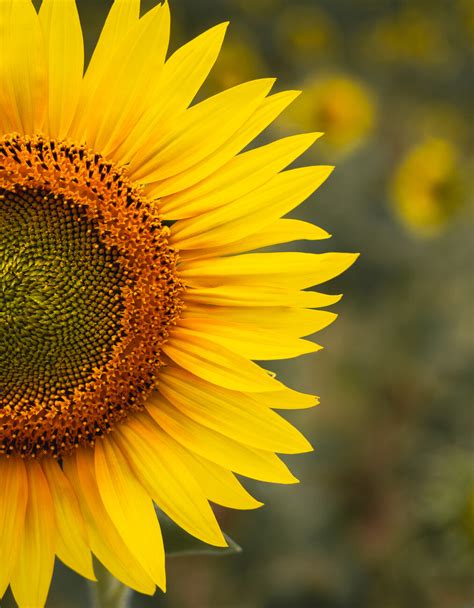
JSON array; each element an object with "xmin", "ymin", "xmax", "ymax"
[{"xmin": 117, "ymin": 414, "xmax": 227, "ymax": 547}]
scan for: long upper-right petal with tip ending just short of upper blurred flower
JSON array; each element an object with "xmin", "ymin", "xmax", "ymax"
[{"xmin": 128, "ymin": 78, "xmax": 275, "ymax": 183}]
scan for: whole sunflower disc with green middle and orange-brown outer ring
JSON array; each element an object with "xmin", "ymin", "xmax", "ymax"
[{"xmin": 0, "ymin": 136, "xmax": 182, "ymax": 458}]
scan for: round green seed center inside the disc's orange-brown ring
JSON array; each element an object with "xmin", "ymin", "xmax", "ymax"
[{"xmin": 0, "ymin": 189, "xmax": 126, "ymax": 407}]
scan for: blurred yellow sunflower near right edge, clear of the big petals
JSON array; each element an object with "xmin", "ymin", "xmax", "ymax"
[{"xmin": 391, "ymin": 138, "xmax": 465, "ymax": 236}]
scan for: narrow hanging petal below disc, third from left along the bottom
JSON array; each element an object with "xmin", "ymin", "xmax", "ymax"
[{"xmin": 42, "ymin": 459, "xmax": 95, "ymax": 580}]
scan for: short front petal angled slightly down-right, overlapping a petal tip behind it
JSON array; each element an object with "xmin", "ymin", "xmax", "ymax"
[{"xmin": 163, "ymin": 328, "xmax": 280, "ymax": 392}]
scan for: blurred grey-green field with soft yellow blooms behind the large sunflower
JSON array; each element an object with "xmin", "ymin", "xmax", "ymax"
[{"xmin": 16, "ymin": 0, "xmax": 474, "ymax": 608}]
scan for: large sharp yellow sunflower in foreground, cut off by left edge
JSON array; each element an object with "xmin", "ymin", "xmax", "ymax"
[{"xmin": 0, "ymin": 0, "xmax": 355, "ymax": 608}]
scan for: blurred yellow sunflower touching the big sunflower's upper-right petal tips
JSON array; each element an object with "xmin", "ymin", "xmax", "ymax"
[{"xmin": 288, "ymin": 74, "xmax": 375, "ymax": 155}]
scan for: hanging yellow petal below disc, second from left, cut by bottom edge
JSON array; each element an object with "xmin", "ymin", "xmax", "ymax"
[{"xmin": 10, "ymin": 460, "xmax": 56, "ymax": 608}]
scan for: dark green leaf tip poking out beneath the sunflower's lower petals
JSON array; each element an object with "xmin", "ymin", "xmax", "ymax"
[{"xmin": 155, "ymin": 507, "xmax": 242, "ymax": 557}]
